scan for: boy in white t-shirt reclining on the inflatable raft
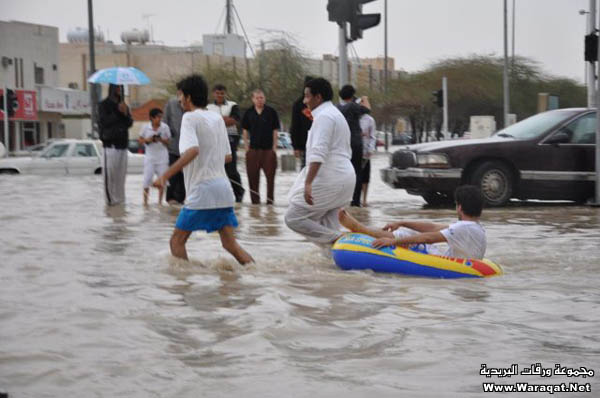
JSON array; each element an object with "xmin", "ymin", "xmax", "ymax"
[{"xmin": 338, "ymin": 185, "xmax": 487, "ymax": 259}]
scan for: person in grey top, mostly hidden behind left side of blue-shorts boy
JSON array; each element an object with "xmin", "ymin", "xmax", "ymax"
[{"xmin": 163, "ymin": 88, "xmax": 185, "ymax": 204}]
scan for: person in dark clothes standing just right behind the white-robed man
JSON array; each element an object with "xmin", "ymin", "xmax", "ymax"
[{"xmin": 338, "ymin": 84, "xmax": 370, "ymax": 207}]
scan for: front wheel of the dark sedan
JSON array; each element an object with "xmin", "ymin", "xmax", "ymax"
[{"xmin": 470, "ymin": 162, "xmax": 513, "ymax": 206}]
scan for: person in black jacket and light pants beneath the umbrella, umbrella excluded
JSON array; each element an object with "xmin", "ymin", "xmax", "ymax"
[{"xmin": 98, "ymin": 84, "xmax": 133, "ymax": 206}]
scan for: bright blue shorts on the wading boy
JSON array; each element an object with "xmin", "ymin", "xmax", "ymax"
[{"xmin": 175, "ymin": 207, "xmax": 238, "ymax": 232}]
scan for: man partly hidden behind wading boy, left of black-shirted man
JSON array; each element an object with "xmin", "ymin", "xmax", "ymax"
[{"xmin": 206, "ymin": 84, "xmax": 245, "ymax": 203}]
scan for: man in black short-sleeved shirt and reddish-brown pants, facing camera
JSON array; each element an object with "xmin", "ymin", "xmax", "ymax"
[{"xmin": 242, "ymin": 90, "xmax": 279, "ymax": 204}]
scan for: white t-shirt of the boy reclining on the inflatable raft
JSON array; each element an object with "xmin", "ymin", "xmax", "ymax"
[{"xmin": 440, "ymin": 221, "xmax": 487, "ymax": 259}]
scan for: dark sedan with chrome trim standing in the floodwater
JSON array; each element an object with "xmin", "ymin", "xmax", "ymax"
[{"xmin": 381, "ymin": 108, "xmax": 596, "ymax": 206}]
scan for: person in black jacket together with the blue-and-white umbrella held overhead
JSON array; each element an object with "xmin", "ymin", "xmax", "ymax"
[{"xmin": 88, "ymin": 66, "xmax": 150, "ymax": 206}]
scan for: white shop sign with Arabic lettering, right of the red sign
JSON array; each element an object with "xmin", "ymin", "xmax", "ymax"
[{"xmin": 40, "ymin": 87, "xmax": 90, "ymax": 115}]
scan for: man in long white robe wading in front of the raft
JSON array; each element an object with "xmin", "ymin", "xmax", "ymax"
[{"xmin": 285, "ymin": 78, "xmax": 356, "ymax": 244}]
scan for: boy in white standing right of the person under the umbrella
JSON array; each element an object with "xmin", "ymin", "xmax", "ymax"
[{"xmin": 138, "ymin": 108, "xmax": 171, "ymax": 206}]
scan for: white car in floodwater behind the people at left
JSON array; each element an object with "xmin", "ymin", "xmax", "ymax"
[{"xmin": 0, "ymin": 139, "xmax": 144, "ymax": 175}]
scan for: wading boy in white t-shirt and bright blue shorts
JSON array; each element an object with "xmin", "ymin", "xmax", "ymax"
[{"xmin": 154, "ymin": 75, "xmax": 254, "ymax": 264}]
